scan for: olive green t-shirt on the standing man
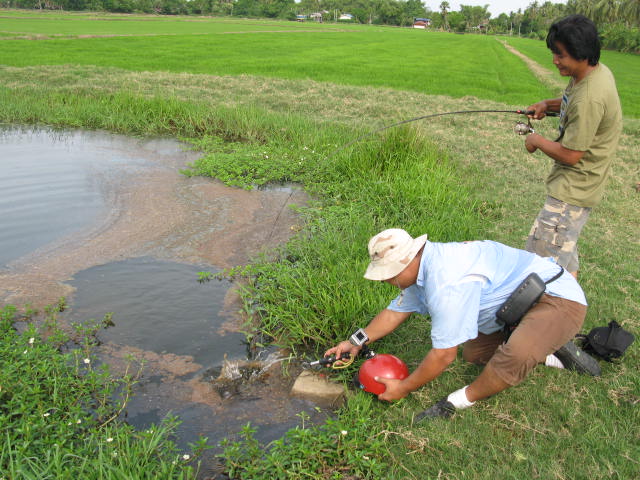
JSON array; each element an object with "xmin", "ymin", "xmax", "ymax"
[{"xmin": 547, "ymin": 63, "xmax": 622, "ymax": 207}]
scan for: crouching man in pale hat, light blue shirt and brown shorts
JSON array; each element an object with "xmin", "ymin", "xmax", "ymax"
[{"xmin": 325, "ymin": 229, "xmax": 600, "ymax": 420}]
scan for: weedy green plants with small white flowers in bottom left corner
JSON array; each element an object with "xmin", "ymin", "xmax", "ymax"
[{"xmin": 0, "ymin": 300, "xmax": 204, "ymax": 480}]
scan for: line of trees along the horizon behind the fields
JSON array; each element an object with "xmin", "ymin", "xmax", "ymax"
[{"xmin": 0, "ymin": 0, "xmax": 640, "ymax": 52}]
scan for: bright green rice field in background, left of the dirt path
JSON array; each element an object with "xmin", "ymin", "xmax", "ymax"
[{"xmin": 2, "ymin": 19, "xmax": 551, "ymax": 106}]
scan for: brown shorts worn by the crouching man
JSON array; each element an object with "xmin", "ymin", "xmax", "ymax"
[{"xmin": 462, "ymin": 294, "xmax": 587, "ymax": 386}]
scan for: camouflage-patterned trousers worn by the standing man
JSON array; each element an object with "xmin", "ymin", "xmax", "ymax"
[{"xmin": 526, "ymin": 196, "xmax": 591, "ymax": 272}]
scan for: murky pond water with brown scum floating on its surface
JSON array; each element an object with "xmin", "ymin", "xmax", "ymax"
[{"xmin": 0, "ymin": 128, "xmax": 323, "ymax": 478}]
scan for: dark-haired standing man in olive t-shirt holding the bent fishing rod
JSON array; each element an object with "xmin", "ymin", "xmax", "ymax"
[{"xmin": 525, "ymin": 15, "xmax": 622, "ymax": 278}]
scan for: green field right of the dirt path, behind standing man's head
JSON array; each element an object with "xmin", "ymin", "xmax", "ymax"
[{"xmin": 504, "ymin": 37, "xmax": 640, "ymax": 118}]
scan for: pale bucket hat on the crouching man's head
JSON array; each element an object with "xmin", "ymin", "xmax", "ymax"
[{"xmin": 364, "ymin": 228, "xmax": 427, "ymax": 280}]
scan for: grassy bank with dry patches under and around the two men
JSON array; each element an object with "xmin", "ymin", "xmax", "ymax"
[{"xmin": 0, "ymin": 13, "xmax": 640, "ymax": 479}]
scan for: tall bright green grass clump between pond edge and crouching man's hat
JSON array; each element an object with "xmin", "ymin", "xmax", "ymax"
[{"xmin": 225, "ymin": 129, "xmax": 479, "ymax": 348}]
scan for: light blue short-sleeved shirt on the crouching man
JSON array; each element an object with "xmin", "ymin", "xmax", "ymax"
[{"xmin": 387, "ymin": 240, "xmax": 587, "ymax": 348}]
